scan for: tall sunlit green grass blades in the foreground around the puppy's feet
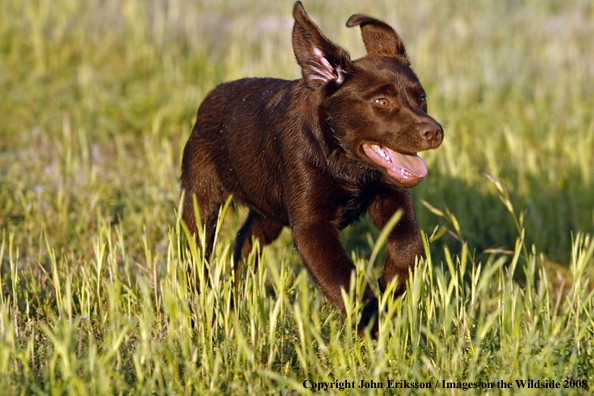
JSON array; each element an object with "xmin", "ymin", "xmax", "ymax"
[{"xmin": 0, "ymin": 187, "xmax": 594, "ymax": 394}]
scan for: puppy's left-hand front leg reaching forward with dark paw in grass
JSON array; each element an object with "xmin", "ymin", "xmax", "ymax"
[{"xmin": 292, "ymin": 220, "xmax": 377, "ymax": 335}]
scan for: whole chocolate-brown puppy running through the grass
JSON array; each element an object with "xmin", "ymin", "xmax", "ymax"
[{"xmin": 181, "ymin": 2, "xmax": 443, "ymax": 332}]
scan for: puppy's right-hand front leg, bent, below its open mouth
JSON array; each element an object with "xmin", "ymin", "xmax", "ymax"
[{"xmin": 369, "ymin": 190, "xmax": 425, "ymax": 295}]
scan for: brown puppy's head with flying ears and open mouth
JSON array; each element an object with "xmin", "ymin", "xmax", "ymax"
[{"xmin": 293, "ymin": 2, "xmax": 444, "ymax": 188}]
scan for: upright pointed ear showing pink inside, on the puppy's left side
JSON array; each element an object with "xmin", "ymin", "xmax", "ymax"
[{"xmin": 293, "ymin": 1, "xmax": 352, "ymax": 89}]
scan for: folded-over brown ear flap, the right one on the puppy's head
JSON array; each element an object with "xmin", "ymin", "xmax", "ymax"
[{"xmin": 347, "ymin": 14, "xmax": 408, "ymax": 63}]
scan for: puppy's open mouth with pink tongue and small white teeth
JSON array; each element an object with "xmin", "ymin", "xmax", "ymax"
[{"xmin": 363, "ymin": 143, "xmax": 427, "ymax": 185}]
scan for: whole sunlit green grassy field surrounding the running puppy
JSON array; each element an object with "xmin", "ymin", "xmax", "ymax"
[{"xmin": 0, "ymin": 0, "xmax": 594, "ymax": 395}]
